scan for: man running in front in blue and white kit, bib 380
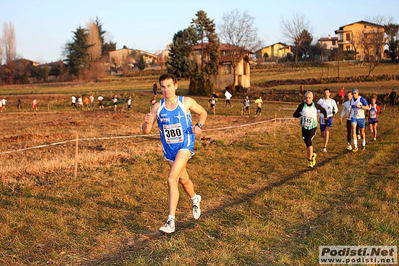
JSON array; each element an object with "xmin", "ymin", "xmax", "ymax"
[{"xmin": 142, "ymin": 73, "xmax": 207, "ymax": 233}]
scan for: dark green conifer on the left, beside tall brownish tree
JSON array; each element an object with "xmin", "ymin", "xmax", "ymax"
[{"xmin": 65, "ymin": 26, "xmax": 90, "ymax": 76}]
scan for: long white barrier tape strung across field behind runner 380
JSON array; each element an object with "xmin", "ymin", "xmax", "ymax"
[{"xmin": 0, "ymin": 118, "xmax": 295, "ymax": 155}]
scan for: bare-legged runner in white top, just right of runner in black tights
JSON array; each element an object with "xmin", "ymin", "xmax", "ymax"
[{"xmin": 317, "ymin": 88, "xmax": 338, "ymax": 152}]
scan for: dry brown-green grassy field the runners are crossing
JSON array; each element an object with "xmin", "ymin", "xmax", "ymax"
[{"xmin": 0, "ymin": 65, "xmax": 399, "ymax": 265}]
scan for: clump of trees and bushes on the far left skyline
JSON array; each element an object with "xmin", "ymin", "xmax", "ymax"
[{"xmin": 0, "ymin": 18, "xmax": 116, "ymax": 84}]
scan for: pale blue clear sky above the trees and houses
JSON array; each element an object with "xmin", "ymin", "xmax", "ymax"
[{"xmin": 0, "ymin": 0, "xmax": 399, "ymax": 63}]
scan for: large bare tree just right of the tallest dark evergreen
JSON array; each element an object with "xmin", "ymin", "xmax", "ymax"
[{"xmin": 218, "ymin": 9, "xmax": 261, "ymax": 88}]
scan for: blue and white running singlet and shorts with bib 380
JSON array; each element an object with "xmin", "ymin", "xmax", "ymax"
[{"xmin": 157, "ymin": 96, "xmax": 195, "ymax": 161}]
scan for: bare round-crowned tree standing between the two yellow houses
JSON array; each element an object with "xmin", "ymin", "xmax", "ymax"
[{"xmin": 280, "ymin": 13, "xmax": 311, "ymax": 63}]
